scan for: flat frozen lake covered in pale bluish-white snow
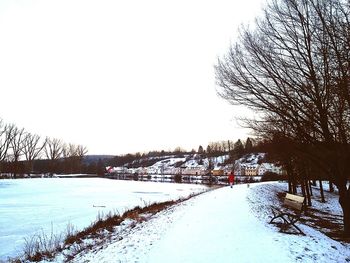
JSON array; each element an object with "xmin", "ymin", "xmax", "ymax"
[{"xmin": 0, "ymin": 178, "xmax": 207, "ymax": 261}]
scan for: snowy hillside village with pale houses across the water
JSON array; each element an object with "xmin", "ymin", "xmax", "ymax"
[{"xmin": 106, "ymin": 153, "xmax": 283, "ymax": 179}]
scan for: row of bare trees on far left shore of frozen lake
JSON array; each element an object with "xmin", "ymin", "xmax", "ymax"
[{"xmin": 0, "ymin": 119, "xmax": 91, "ymax": 178}]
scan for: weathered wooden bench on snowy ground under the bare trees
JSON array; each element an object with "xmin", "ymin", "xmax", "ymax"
[{"xmin": 270, "ymin": 193, "xmax": 305, "ymax": 235}]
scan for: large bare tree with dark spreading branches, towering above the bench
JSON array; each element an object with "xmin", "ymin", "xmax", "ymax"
[{"xmin": 216, "ymin": 0, "xmax": 350, "ymax": 236}]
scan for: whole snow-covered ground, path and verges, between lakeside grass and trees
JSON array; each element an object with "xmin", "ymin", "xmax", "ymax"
[{"xmin": 61, "ymin": 183, "xmax": 350, "ymax": 263}]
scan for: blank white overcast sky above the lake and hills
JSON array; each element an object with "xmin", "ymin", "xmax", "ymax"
[{"xmin": 0, "ymin": 0, "xmax": 264, "ymax": 154}]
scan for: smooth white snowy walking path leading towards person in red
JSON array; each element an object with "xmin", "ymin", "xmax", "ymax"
[{"xmin": 150, "ymin": 185, "xmax": 290, "ymax": 263}]
